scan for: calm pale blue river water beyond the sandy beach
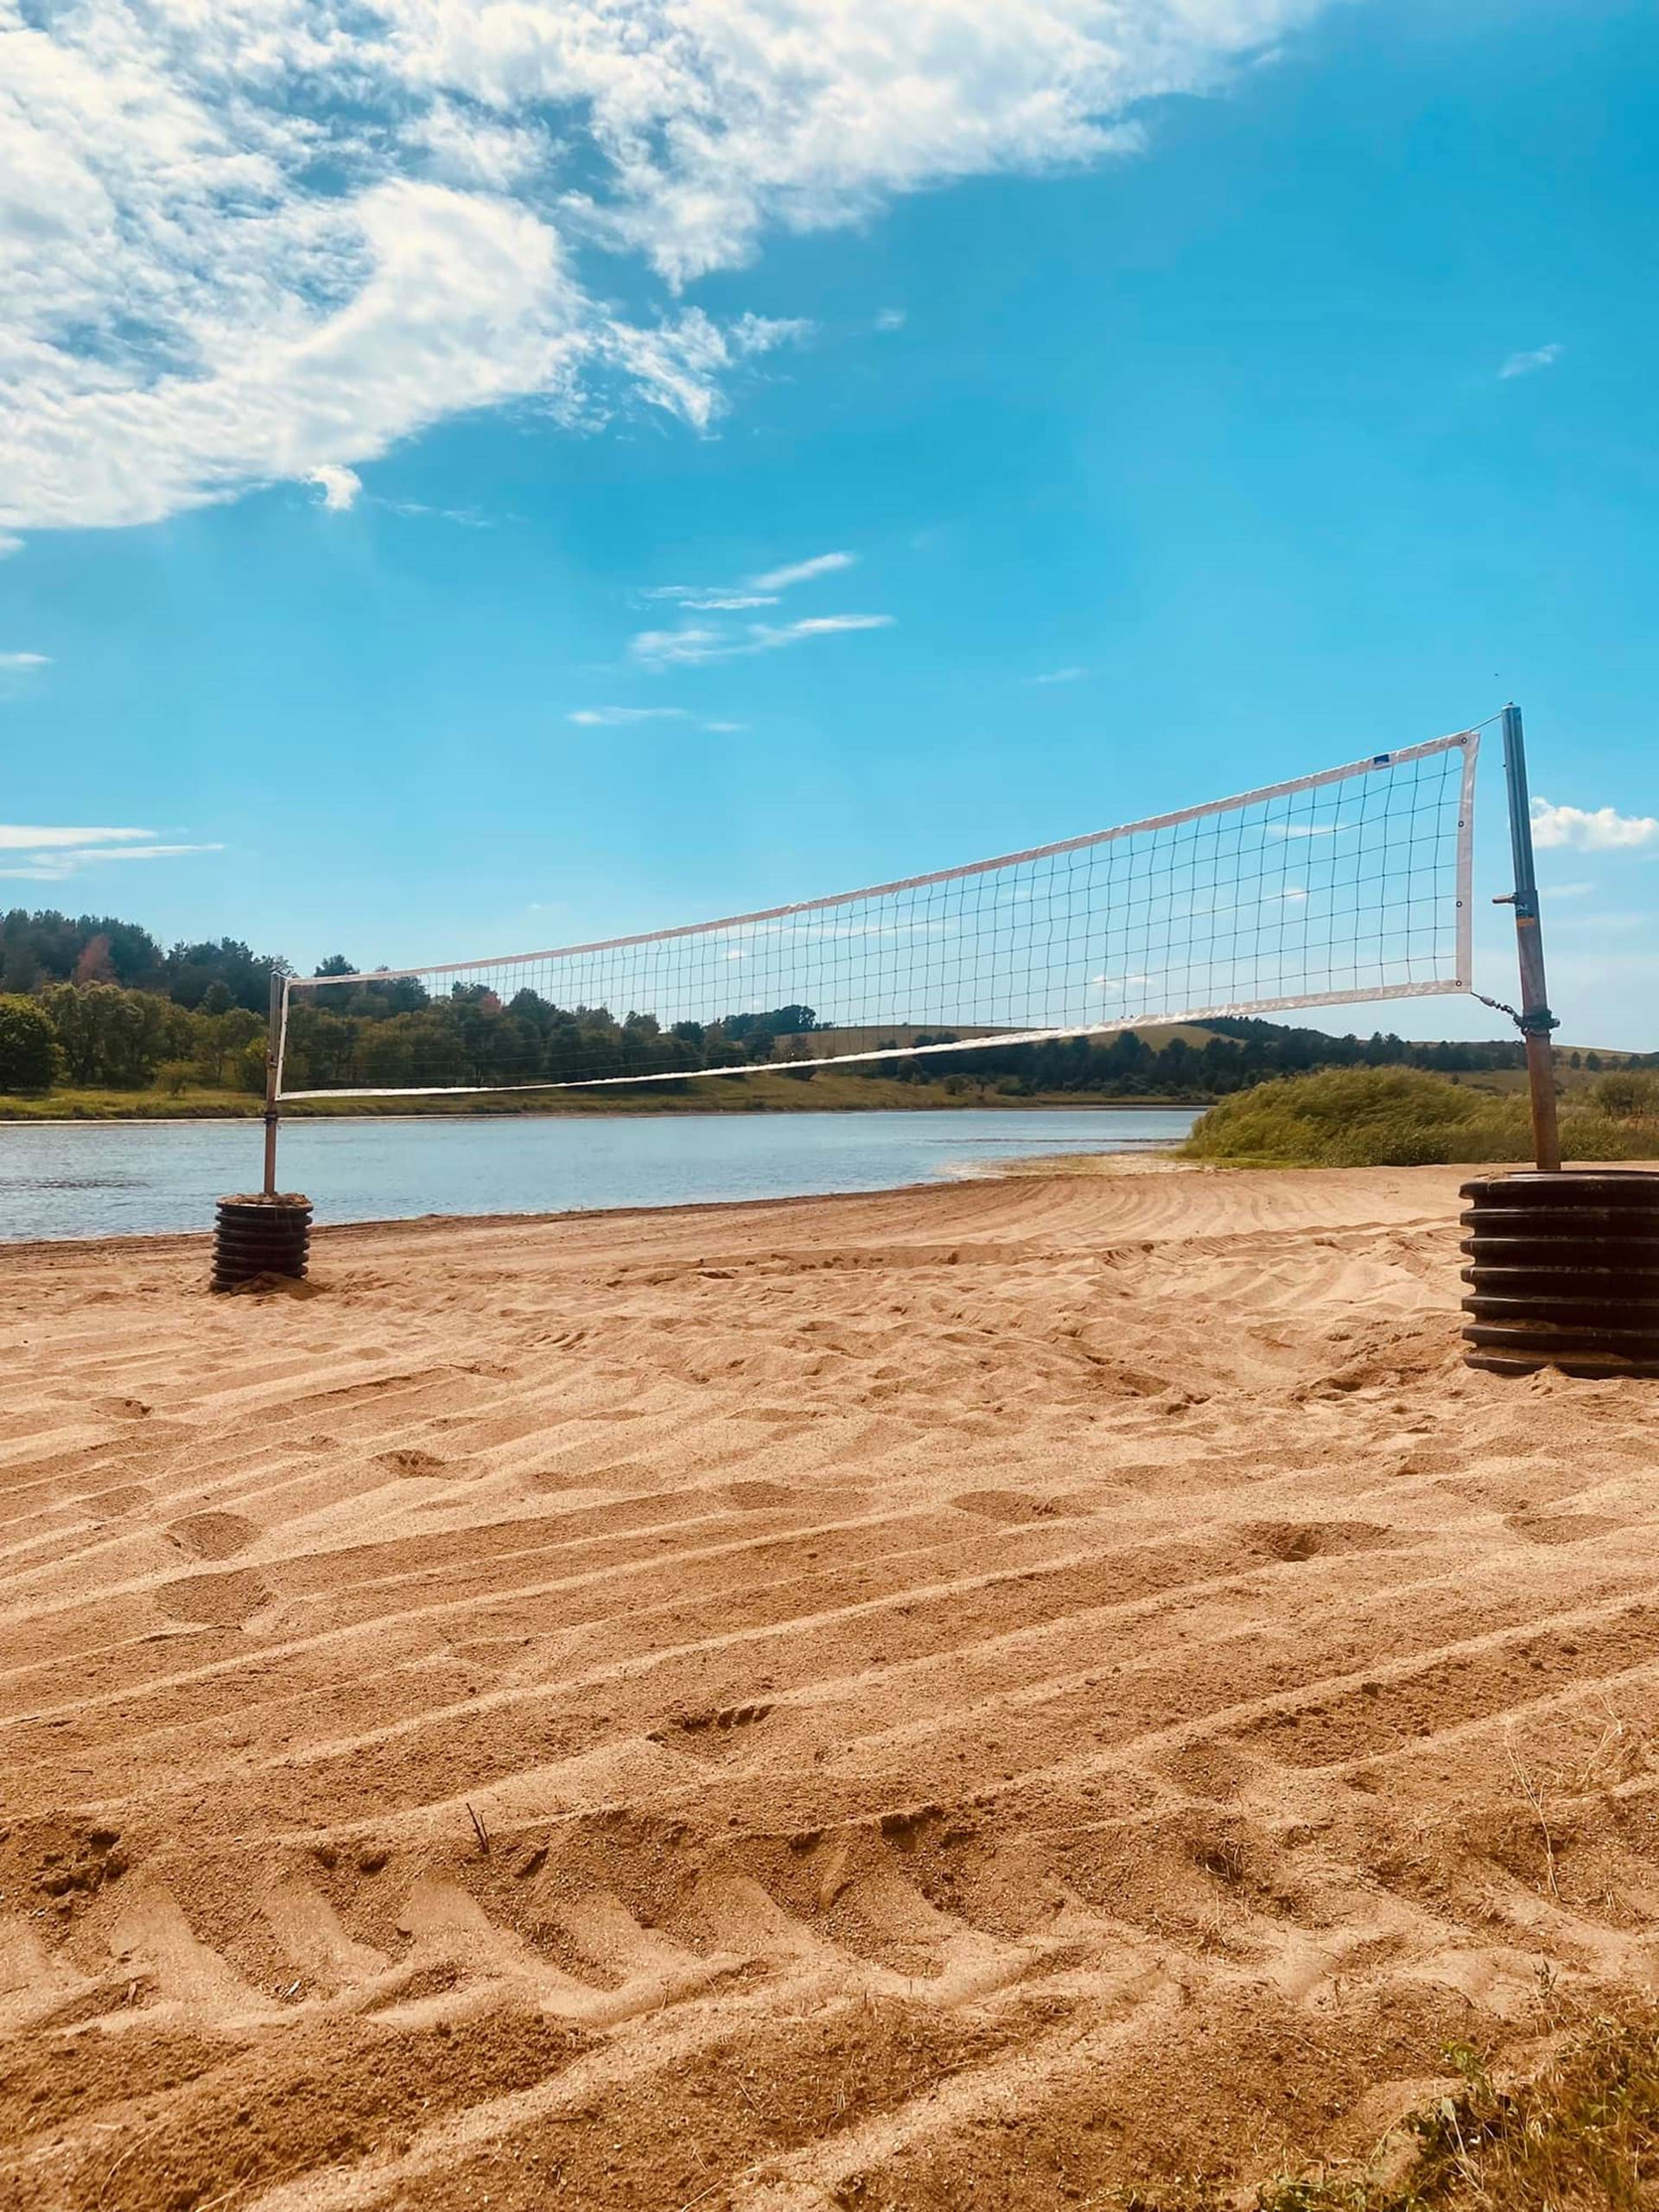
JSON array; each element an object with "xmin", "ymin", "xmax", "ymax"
[{"xmin": 0, "ymin": 1106, "xmax": 1192, "ymax": 1241}]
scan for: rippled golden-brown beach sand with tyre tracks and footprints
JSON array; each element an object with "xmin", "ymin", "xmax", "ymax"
[{"xmin": 0, "ymin": 1168, "xmax": 1659, "ymax": 2212}]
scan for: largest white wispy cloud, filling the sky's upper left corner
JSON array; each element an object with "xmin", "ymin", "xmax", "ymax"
[{"xmin": 0, "ymin": 0, "xmax": 1330, "ymax": 537}]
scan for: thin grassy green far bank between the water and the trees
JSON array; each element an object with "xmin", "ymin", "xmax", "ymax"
[{"xmin": 0, "ymin": 1068, "xmax": 1210, "ymax": 1123}]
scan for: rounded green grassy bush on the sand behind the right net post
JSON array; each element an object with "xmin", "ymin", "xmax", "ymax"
[{"xmin": 1185, "ymin": 1068, "xmax": 1652, "ymax": 1168}]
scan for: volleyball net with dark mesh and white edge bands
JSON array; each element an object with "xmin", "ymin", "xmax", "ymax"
[{"xmin": 279, "ymin": 732, "xmax": 1478, "ymax": 1099}]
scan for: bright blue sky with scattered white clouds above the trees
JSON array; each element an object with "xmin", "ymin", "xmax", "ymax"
[{"xmin": 0, "ymin": 0, "xmax": 1659, "ymax": 1048}]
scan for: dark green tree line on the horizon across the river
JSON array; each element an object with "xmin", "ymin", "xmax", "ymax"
[{"xmin": 0, "ymin": 909, "xmax": 1645, "ymax": 1097}]
